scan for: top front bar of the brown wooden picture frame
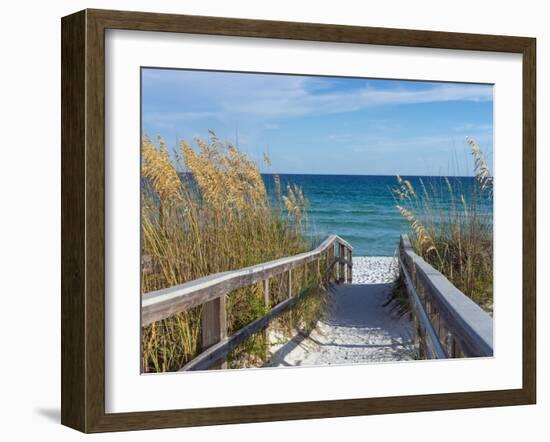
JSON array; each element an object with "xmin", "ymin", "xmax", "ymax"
[{"xmin": 88, "ymin": 9, "xmax": 533, "ymax": 53}]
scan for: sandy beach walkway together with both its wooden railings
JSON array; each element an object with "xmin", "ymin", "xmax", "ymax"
[{"xmin": 141, "ymin": 234, "xmax": 493, "ymax": 371}]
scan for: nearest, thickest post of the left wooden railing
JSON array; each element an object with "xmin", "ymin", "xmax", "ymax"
[{"xmin": 201, "ymin": 295, "xmax": 227, "ymax": 369}]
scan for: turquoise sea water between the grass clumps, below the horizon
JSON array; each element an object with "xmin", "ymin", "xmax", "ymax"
[{"xmin": 263, "ymin": 174, "xmax": 492, "ymax": 256}]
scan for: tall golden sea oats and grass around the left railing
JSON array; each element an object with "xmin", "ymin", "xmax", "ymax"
[{"xmin": 141, "ymin": 132, "xmax": 330, "ymax": 372}]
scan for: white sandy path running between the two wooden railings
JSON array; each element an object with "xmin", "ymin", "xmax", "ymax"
[{"xmin": 270, "ymin": 257, "xmax": 414, "ymax": 366}]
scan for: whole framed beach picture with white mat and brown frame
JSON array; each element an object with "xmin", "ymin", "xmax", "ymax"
[{"xmin": 61, "ymin": 10, "xmax": 536, "ymax": 432}]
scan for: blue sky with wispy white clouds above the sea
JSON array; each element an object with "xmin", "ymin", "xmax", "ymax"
[{"xmin": 142, "ymin": 68, "xmax": 493, "ymax": 175}]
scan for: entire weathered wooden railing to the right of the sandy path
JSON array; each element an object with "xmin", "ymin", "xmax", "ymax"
[{"xmin": 399, "ymin": 235, "xmax": 493, "ymax": 359}]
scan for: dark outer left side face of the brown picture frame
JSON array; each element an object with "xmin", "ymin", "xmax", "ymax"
[{"xmin": 61, "ymin": 11, "xmax": 87, "ymax": 431}]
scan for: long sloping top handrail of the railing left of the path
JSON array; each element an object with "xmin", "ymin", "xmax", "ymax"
[{"xmin": 141, "ymin": 235, "xmax": 353, "ymax": 326}]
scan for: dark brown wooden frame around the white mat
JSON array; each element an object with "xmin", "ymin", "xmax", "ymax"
[{"xmin": 61, "ymin": 6, "xmax": 536, "ymax": 432}]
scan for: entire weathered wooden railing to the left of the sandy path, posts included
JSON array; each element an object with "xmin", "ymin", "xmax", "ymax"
[{"xmin": 141, "ymin": 235, "xmax": 353, "ymax": 370}]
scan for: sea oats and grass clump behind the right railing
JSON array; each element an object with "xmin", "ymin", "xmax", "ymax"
[{"xmin": 392, "ymin": 139, "xmax": 493, "ymax": 311}]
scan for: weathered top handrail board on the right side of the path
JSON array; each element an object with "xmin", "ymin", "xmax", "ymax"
[{"xmin": 400, "ymin": 235, "xmax": 493, "ymax": 357}]
